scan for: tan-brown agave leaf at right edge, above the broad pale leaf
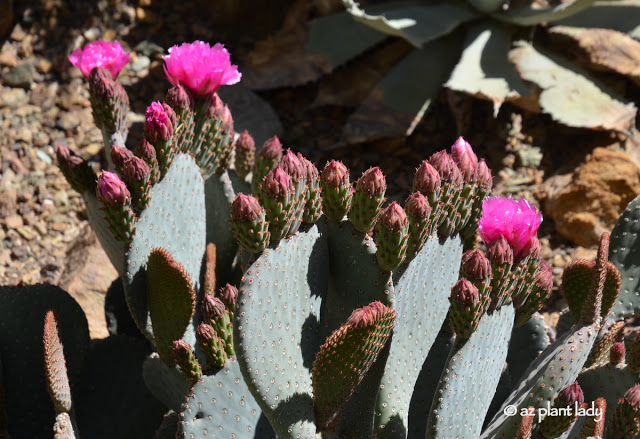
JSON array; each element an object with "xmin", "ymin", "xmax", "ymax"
[{"xmin": 550, "ymin": 26, "xmax": 640, "ymax": 84}]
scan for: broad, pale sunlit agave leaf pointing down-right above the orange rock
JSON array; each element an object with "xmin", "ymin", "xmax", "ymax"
[{"xmin": 509, "ymin": 41, "xmax": 637, "ymax": 132}]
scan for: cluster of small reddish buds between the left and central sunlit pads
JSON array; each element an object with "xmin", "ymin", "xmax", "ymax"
[{"xmin": 196, "ymin": 284, "xmax": 238, "ymax": 367}]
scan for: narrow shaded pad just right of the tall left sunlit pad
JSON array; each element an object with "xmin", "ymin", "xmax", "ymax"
[{"xmin": 204, "ymin": 171, "xmax": 242, "ymax": 285}]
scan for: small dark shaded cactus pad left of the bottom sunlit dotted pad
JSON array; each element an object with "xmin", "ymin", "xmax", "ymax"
[{"xmin": 142, "ymin": 353, "xmax": 191, "ymax": 412}]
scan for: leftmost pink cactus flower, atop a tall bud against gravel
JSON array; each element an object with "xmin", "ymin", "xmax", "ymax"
[{"xmin": 69, "ymin": 40, "xmax": 129, "ymax": 78}]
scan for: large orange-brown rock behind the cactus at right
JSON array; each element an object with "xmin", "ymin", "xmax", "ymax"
[{"xmin": 544, "ymin": 148, "xmax": 640, "ymax": 247}]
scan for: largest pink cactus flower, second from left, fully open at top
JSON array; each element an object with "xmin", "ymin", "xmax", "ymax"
[{"xmin": 163, "ymin": 41, "xmax": 242, "ymax": 97}]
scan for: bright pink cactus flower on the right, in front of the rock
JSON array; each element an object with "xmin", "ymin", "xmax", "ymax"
[{"xmin": 478, "ymin": 197, "xmax": 542, "ymax": 259}]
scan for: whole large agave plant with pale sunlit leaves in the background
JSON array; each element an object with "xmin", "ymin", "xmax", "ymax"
[{"xmin": 248, "ymin": 0, "xmax": 640, "ymax": 142}]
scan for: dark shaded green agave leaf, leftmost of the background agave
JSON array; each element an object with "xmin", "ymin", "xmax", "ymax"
[{"xmin": 306, "ymin": 12, "xmax": 388, "ymax": 69}]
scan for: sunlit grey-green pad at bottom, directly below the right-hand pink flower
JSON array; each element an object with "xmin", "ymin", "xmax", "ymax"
[{"xmin": 425, "ymin": 305, "xmax": 515, "ymax": 439}]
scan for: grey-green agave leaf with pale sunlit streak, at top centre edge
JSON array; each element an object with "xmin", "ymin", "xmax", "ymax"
[{"xmin": 343, "ymin": 0, "xmax": 478, "ymax": 47}]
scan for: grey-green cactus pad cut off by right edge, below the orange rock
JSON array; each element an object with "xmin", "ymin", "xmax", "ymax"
[{"xmin": 609, "ymin": 196, "xmax": 640, "ymax": 320}]
